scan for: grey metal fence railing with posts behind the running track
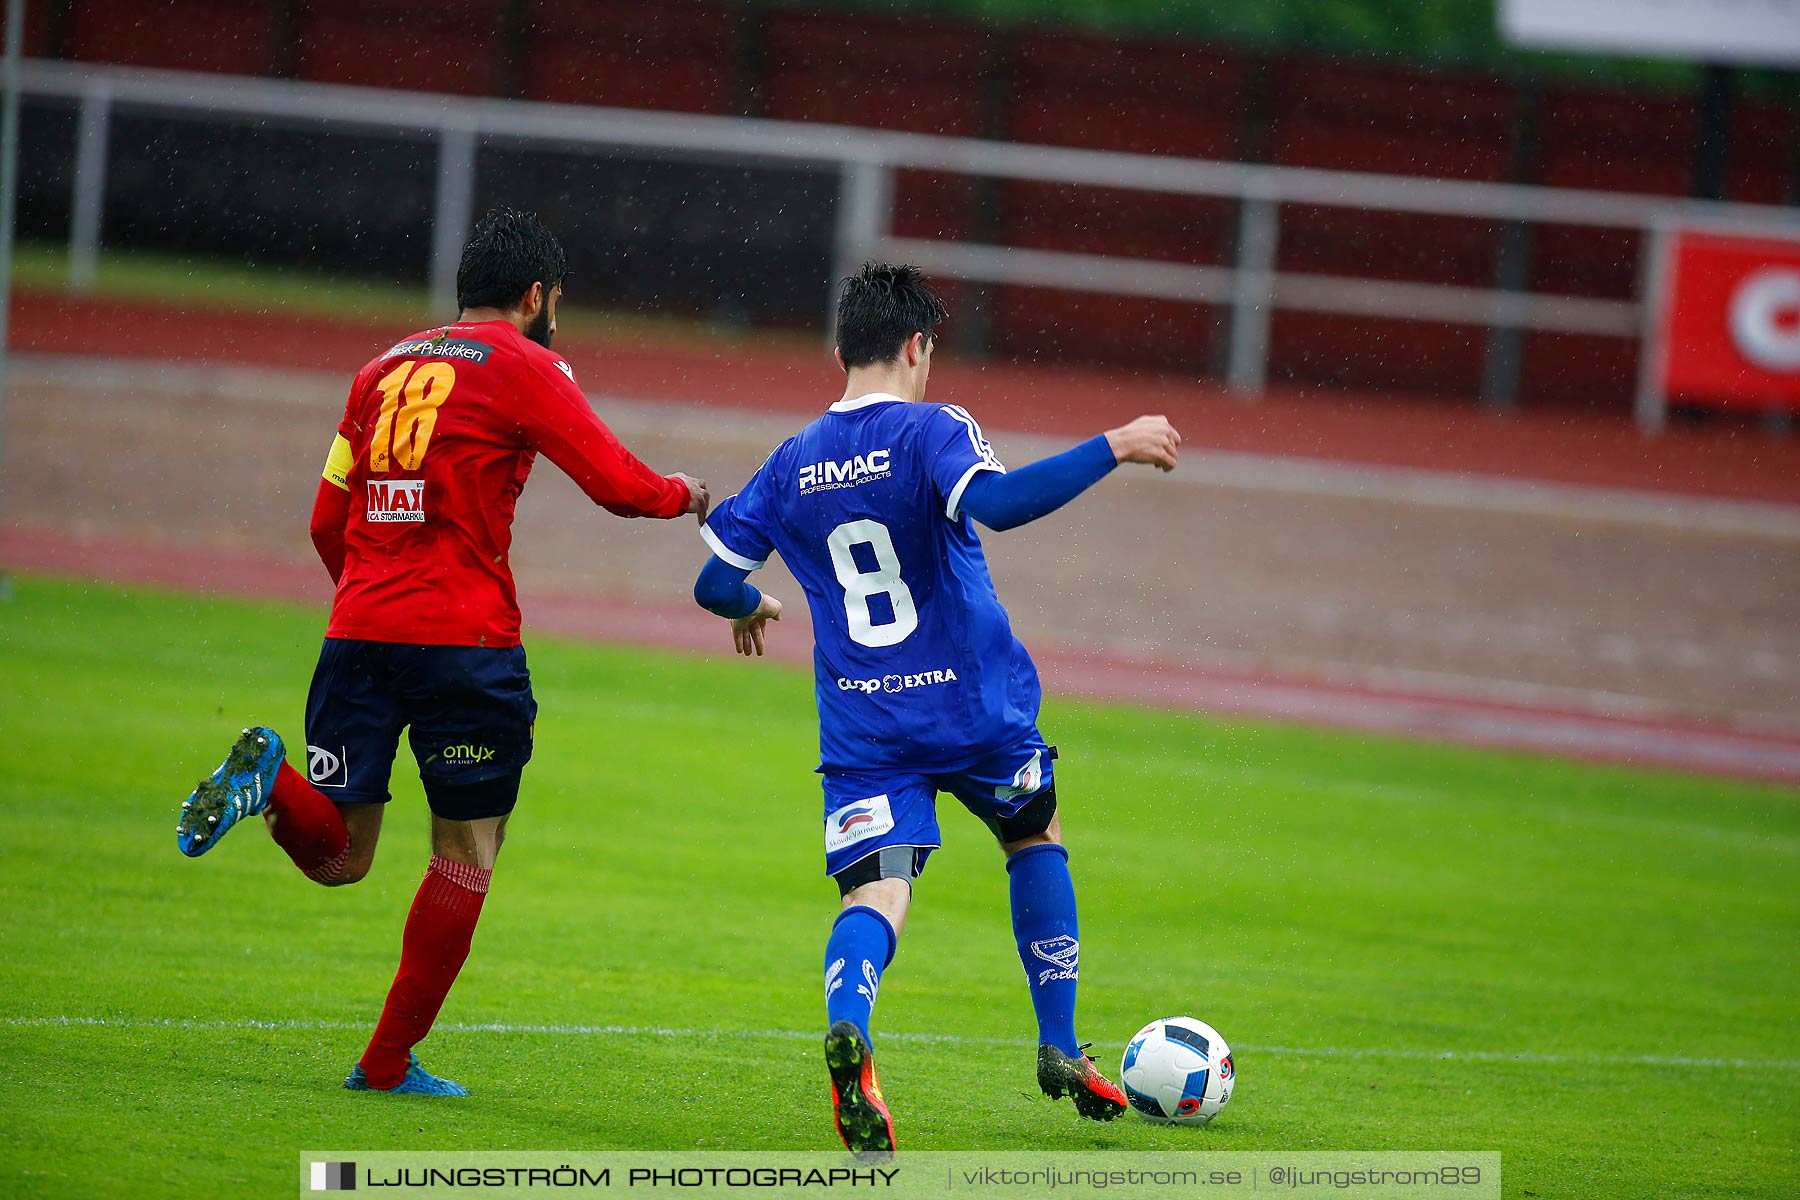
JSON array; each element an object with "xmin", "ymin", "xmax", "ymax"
[{"xmin": 22, "ymin": 61, "xmax": 1800, "ymax": 426}]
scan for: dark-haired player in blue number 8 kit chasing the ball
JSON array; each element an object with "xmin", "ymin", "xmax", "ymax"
[{"xmin": 695, "ymin": 263, "xmax": 1181, "ymax": 1151}]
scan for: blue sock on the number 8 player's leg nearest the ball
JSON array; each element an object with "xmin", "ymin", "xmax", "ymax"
[{"xmin": 1006, "ymin": 844, "xmax": 1082, "ymax": 1056}]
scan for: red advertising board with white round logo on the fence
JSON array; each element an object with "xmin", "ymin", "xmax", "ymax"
[{"xmin": 1651, "ymin": 228, "xmax": 1800, "ymax": 412}]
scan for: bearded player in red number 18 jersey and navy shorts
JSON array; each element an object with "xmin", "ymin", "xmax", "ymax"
[{"xmin": 176, "ymin": 209, "xmax": 707, "ymax": 1096}]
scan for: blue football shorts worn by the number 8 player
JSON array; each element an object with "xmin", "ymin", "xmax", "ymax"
[{"xmin": 824, "ymin": 727, "xmax": 1055, "ymax": 874}]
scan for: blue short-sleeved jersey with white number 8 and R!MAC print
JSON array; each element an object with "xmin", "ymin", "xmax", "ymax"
[{"xmin": 702, "ymin": 394, "xmax": 1040, "ymax": 772}]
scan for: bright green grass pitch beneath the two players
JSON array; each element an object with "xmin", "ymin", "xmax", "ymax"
[{"xmin": 0, "ymin": 576, "xmax": 1800, "ymax": 1198}]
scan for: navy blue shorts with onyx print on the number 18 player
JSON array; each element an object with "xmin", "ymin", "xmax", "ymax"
[{"xmin": 306, "ymin": 637, "xmax": 538, "ymax": 820}]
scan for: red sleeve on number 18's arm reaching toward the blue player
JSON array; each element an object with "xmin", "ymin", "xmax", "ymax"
[{"xmin": 518, "ymin": 358, "xmax": 688, "ymax": 520}]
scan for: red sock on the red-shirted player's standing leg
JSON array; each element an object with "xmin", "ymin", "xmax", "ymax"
[{"xmin": 362, "ymin": 855, "xmax": 493, "ymax": 1088}]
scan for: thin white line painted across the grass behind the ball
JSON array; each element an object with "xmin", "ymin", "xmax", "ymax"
[{"xmin": 0, "ymin": 1016, "xmax": 1800, "ymax": 1070}]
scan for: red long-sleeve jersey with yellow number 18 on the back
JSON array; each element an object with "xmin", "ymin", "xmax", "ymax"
[{"xmin": 311, "ymin": 320, "xmax": 688, "ymax": 646}]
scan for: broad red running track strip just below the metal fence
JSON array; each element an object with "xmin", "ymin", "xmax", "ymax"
[{"xmin": 13, "ymin": 291, "xmax": 1800, "ymax": 504}]
